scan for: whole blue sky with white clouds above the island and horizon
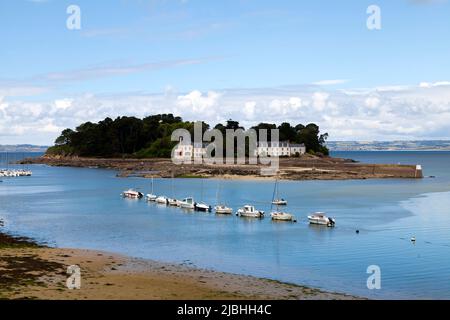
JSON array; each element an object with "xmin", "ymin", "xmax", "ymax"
[{"xmin": 0, "ymin": 0, "xmax": 450, "ymax": 144}]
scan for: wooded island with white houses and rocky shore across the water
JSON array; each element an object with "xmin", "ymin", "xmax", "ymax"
[{"xmin": 21, "ymin": 114, "xmax": 423, "ymax": 180}]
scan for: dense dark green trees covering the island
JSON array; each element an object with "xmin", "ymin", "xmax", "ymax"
[{"xmin": 47, "ymin": 114, "xmax": 328, "ymax": 158}]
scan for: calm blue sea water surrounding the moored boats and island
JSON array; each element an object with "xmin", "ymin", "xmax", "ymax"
[{"xmin": 0, "ymin": 152, "xmax": 450, "ymax": 299}]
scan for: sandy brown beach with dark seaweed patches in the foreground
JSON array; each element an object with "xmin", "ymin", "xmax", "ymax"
[{"xmin": 0, "ymin": 230, "xmax": 361, "ymax": 300}]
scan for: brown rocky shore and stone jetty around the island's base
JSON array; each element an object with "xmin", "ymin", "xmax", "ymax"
[{"xmin": 20, "ymin": 155, "xmax": 423, "ymax": 180}]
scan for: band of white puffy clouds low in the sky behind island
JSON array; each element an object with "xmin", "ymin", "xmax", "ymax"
[{"xmin": 0, "ymin": 81, "xmax": 450, "ymax": 144}]
